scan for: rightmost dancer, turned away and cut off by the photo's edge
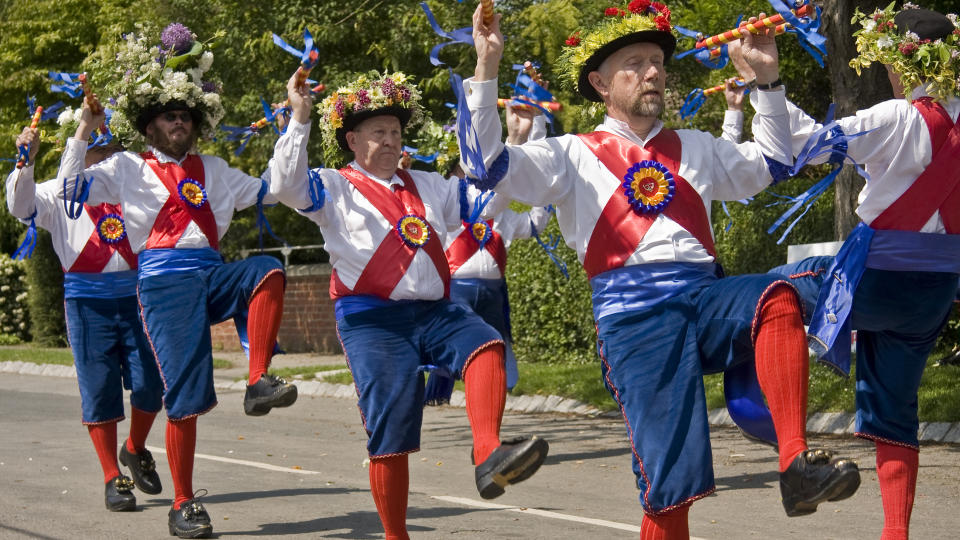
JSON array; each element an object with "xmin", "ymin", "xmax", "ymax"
[{"xmin": 754, "ymin": 4, "xmax": 960, "ymax": 540}]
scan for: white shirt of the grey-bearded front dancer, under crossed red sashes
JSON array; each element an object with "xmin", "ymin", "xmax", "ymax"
[{"xmin": 464, "ymin": 79, "xmax": 793, "ymax": 266}]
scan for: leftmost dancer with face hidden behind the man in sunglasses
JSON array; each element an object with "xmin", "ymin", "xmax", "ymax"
[{"xmin": 7, "ymin": 128, "xmax": 162, "ymax": 512}]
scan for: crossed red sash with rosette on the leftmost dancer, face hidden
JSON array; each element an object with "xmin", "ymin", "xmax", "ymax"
[{"xmin": 66, "ymin": 203, "xmax": 137, "ymax": 274}]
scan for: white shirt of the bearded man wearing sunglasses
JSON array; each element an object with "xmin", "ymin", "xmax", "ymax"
[{"xmin": 57, "ymin": 137, "xmax": 277, "ymax": 253}]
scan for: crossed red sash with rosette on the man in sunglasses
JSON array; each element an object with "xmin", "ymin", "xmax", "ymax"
[{"xmin": 140, "ymin": 152, "xmax": 220, "ymax": 250}]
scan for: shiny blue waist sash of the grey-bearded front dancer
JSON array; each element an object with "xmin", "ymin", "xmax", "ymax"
[{"xmin": 590, "ymin": 262, "xmax": 717, "ymax": 320}]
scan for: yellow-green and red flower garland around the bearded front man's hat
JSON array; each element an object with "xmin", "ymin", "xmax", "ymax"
[{"xmin": 558, "ymin": 0, "xmax": 673, "ymax": 97}]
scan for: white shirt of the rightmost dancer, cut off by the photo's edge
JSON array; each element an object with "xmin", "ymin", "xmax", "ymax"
[{"xmin": 753, "ymin": 88, "xmax": 960, "ymax": 234}]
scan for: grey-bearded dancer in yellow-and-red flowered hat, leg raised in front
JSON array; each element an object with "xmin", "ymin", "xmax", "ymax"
[{"xmin": 461, "ymin": 0, "xmax": 860, "ymax": 538}]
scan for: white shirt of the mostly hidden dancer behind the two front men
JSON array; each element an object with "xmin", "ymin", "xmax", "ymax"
[{"xmin": 443, "ymin": 201, "xmax": 550, "ymax": 279}]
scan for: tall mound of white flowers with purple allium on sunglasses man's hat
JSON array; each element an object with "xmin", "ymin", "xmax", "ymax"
[{"xmin": 85, "ymin": 23, "xmax": 225, "ymax": 144}]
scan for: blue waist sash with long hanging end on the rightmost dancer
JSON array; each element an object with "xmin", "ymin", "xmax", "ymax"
[{"xmin": 808, "ymin": 223, "xmax": 960, "ymax": 373}]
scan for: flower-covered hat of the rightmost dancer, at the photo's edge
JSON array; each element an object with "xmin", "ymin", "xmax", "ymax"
[{"xmin": 850, "ymin": 2, "xmax": 960, "ymax": 99}]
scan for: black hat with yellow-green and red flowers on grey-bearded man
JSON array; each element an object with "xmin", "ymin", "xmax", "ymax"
[{"xmin": 559, "ymin": 0, "xmax": 677, "ymax": 102}]
